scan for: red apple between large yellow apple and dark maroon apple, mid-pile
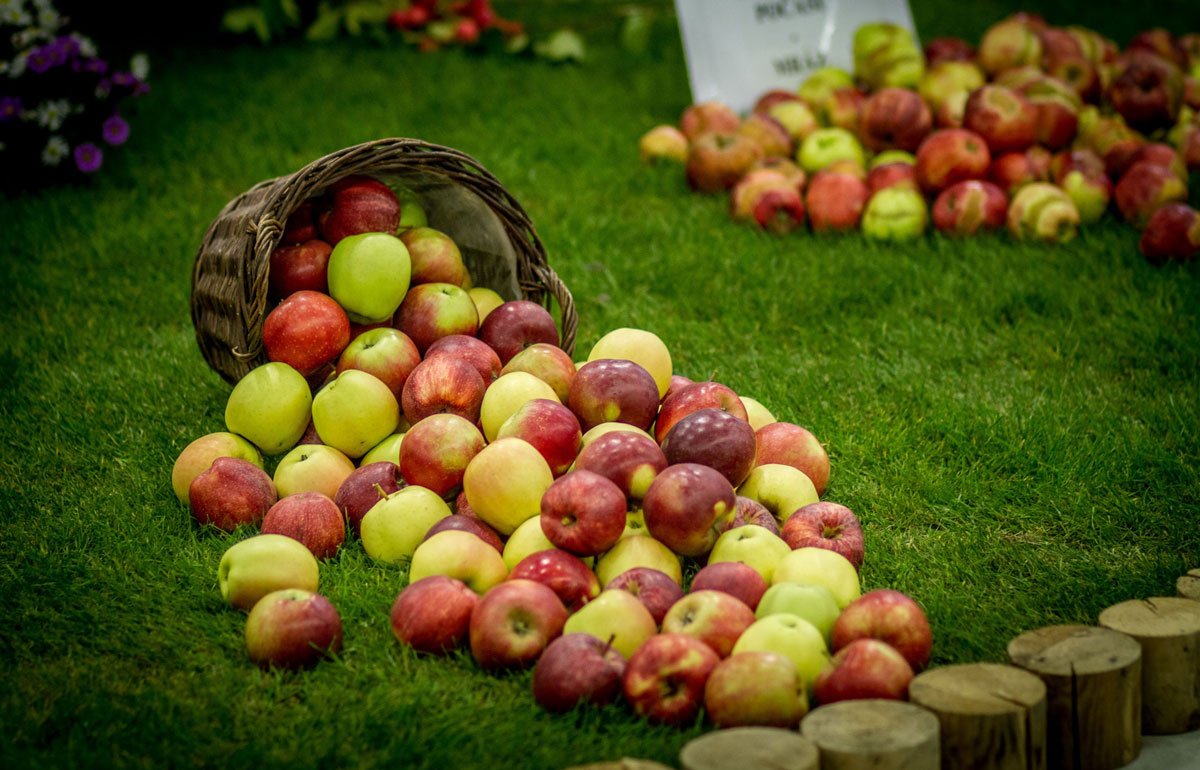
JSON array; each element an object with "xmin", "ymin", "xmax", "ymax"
[{"xmin": 541, "ymin": 469, "xmax": 625, "ymax": 557}]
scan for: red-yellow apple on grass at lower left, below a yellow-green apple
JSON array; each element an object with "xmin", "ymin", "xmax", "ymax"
[{"xmin": 245, "ymin": 588, "xmax": 342, "ymax": 668}]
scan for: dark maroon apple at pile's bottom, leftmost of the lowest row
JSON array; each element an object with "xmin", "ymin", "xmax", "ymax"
[{"xmin": 533, "ymin": 633, "xmax": 625, "ymax": 714}]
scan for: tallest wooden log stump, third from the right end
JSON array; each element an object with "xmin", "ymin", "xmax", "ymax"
[{"xmin": 1008, "ymin": 625, "xmax": 1141, "ymax": 770}]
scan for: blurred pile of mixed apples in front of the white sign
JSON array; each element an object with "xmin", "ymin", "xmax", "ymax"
[{"xmin": 640, "ymin": 13, "xmax": 1200, "ymax": 260}]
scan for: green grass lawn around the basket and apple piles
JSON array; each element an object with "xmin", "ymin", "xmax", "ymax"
[{"xmin": 0, "ymin": 0, "xmax": 1200, "ymax": 769}]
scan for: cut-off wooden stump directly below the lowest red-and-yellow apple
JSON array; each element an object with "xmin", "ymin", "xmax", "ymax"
[{"xmin": 679, "ymin": 727, "xmax": 820, "ymax": 770}]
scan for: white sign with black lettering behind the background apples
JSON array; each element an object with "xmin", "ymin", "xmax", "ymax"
[{"xmin": 676, "ymin": 0, "xmax": 919, "ymax": 112}]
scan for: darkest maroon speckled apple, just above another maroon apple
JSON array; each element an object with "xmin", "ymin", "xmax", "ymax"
[{"xmin": 662, "ymin": 407, "xmax": 757, "ymax": 487}]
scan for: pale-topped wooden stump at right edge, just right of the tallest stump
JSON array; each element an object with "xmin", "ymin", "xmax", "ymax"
[{"xmin": 1100, "ymin": 596, "xmax": 1200, "ymax": 735}]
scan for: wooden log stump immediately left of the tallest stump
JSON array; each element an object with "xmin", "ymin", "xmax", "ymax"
[{"xmin": 908, "ymin": 663, "xmax": 1046, "ymax": 770}]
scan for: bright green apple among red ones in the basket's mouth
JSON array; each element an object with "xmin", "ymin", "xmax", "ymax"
[{"xmin": 328, "ymin": 233, "xmax": 413, "ymax": 324}]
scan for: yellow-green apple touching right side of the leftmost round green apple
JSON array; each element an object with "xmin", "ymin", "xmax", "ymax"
[{"xmin": 312, "ymin": 369, "xmax": 400, "ymax": 457}]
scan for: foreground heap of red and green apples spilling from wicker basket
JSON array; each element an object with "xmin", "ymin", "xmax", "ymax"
[{"xmin": 172, "ymin": 176, "xmax": 931, "ymax": 727}]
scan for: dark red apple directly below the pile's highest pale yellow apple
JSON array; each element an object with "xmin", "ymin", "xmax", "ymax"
[{"xmin": 566, "ymin": 359, "xmax": 659, "ymax": 431}]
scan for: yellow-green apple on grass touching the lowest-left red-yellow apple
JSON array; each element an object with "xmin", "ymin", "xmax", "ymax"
[{"xmin": 217, "ymin": 535, "xmax": 320, "ymax": 610}]
